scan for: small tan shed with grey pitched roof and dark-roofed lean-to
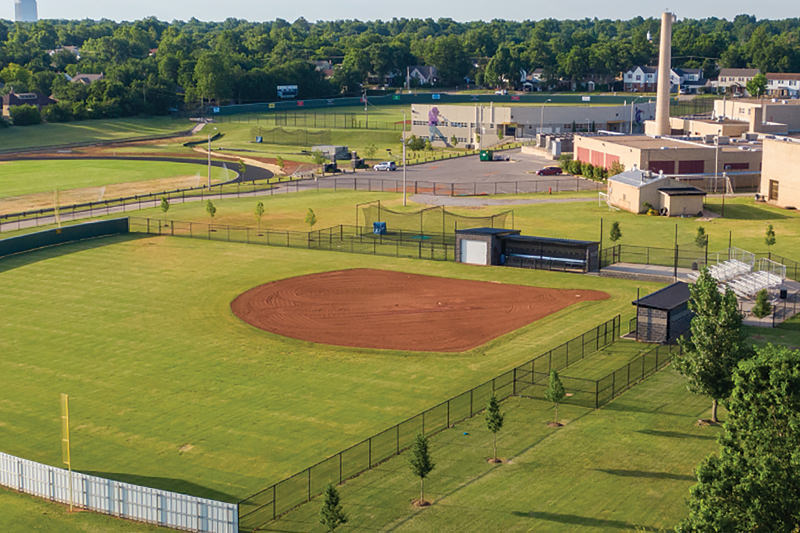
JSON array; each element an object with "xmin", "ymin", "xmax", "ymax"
[{"xmin": 608, "ymin": 168, "xmax": 706, "ymax": 216}]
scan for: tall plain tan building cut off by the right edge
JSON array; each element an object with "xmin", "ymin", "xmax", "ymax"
[{"xmin": 761, "ymin": 138, "xmax": 800, "ymax": 209}]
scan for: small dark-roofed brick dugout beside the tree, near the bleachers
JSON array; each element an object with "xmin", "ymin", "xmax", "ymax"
[{"xmin": 633, "ymin": 282, "xmax": 694, "ymax": 344}]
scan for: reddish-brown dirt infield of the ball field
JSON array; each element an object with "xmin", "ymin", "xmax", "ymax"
[{"xmin": 231, "ymin": 269, "xmax": 608, "ymax": 352}]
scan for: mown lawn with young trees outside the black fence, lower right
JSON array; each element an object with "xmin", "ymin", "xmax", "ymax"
[{"xmin": 268, "ymin": 368, "xmax": 720, "ymax": 533}]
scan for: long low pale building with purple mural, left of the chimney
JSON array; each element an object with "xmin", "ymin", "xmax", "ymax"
[{"xmin": 411, "ymin": 102, "xmax": 655, "ymax": 147}]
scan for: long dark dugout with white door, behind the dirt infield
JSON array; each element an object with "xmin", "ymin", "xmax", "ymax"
[{"xmin": 456, "ymin": 228, "xmax": 600, "ymax": 272}]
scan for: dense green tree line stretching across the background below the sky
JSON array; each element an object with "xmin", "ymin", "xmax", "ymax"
[{"xmin": 0, "ymin": 15, "xmax": 800, "ymax": 120}]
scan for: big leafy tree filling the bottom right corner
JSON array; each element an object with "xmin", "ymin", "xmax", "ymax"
[{"xmin": 676, "ymin": 345, "xmax": 800, "ymax": 533}]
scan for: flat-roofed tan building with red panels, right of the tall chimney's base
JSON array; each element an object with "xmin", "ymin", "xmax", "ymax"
[{"xmin": 574, "ymin": 135, "xmax": 761, "ymax": 175}]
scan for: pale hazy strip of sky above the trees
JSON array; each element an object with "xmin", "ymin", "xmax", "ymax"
[{"xmin": 0, "ymin": 0, "xmax": 800, "ymax": 21}]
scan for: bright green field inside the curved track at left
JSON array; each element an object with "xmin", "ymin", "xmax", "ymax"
[{"xmin": 0, "ymin": 159, "xmax": 235, "ymax": 198}]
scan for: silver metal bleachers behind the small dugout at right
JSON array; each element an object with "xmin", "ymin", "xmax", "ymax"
[{"xmin": 688, "ymin": 248, "xmax": 786, "ymax": 299}]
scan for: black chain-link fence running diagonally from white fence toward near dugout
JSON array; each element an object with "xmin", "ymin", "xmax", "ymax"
[{"xmin": 239, "ymin": 315, "xmax": 621, "ymax": 531}]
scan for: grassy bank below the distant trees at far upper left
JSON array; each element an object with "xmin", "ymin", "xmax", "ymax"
[{"xmin": 0, "ymin": 117, "xmax": 192, "ymax": 150}]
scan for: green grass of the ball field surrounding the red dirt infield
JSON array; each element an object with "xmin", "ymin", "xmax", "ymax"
[{"xmin": 0, "ymin": 233, "xmax": 656, "ymax": 501}]
